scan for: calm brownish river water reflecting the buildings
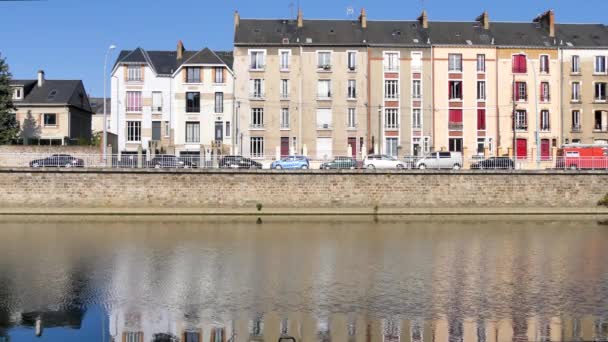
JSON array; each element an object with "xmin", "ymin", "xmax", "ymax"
[{"xmin": 0, "ymin": 217, "xmax": 608, "ymax": 342}]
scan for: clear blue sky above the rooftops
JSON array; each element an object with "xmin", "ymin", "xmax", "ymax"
[{"xmin": 0, "ymin": 0, "xmax": 608, "ymax": 96}]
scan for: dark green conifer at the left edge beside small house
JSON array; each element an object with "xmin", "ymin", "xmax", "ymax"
[{"xmin": 0, "ymin": 55, "xmax": 19, "ymax": 145}]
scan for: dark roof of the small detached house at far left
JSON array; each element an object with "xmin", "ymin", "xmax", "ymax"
[{"xmin": 9, "ymin": 80, "xmax": 91, "ymax": 112}]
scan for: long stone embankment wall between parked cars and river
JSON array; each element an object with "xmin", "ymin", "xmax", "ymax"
[{"xmin": 0, "ymin": 169, "xmax": 608, "ymax": 210}]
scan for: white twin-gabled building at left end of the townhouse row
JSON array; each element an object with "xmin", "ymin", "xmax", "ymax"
[{"xmin": 110, "ymin": 41, "xmax": 234, "ymax": 155}]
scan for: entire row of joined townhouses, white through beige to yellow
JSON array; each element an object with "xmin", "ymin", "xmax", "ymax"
[{"xmin": 112, "ymin": 10, "xmax": 608, "ymax": 159}]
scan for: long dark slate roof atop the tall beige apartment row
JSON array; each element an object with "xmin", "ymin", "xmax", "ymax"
[{"xmin": 234, "ymin": 19, "xmax": 608, "ymax": 48}]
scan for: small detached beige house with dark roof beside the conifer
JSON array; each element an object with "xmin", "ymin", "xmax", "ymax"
[{"xmin": 10, "ymin": 70, "xmax": 92, "ymax": 145}]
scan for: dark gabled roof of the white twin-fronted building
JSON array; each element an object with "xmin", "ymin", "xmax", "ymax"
[{"xmin": 114, "ymin": 47, "xmax": 232, "ymax": 75}]
